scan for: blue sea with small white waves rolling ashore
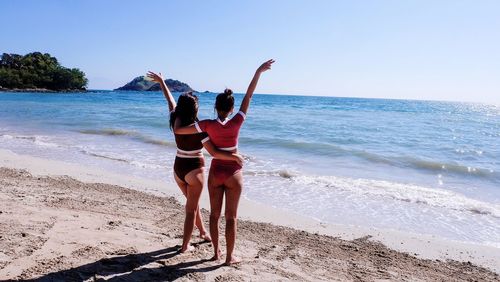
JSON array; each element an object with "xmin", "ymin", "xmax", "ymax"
[{"xmin": 0, "ymin": 92, "xmax": 500, "ymax": 247}]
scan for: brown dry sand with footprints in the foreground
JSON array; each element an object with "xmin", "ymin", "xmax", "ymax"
[{"xmin": 0, "ymin": 168, "xmax": 500, "ymax": 281}]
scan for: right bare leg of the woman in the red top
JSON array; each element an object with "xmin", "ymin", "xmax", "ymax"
[{"xmin": 224, "ymin": 172, "xmax": 243, "ymax": 265}]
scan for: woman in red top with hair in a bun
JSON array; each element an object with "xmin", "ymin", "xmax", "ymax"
[{"xmin": 175, "ymin": 60, "xmax": 274, "ymax": 265}]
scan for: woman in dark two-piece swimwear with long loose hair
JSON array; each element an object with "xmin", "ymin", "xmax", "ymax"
[{"xmin": 148, "ymin": 72, "xmax": 243, "ymax": 252}]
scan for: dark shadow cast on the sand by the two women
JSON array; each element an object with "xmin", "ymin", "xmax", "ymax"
[{"xmin": 25, "ymin": 243, "xmax": 222, "ymax": 281}]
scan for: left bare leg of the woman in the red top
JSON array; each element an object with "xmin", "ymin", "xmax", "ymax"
[{"xmin": 208, "ymin": 175, "xmax": 224, "ymax": 260}]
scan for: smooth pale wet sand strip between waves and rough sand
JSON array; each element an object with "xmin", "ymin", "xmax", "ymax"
[{"xmin": 0, "ymin": 149, "xmax": 500, "ymax": 273}]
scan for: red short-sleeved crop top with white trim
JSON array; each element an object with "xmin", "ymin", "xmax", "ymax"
[{"xmin": 194, "ymin": 111, "xmax": 246, "ymax": 151}]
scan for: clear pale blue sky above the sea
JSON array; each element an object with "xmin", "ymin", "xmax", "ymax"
[{"xmin": 0, "ymin": 0, "xmax": 500, "ymax": 103}]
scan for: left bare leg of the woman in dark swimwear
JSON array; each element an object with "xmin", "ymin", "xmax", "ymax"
[{"xmin": 177, "ymin": 169, "xmax": 203, "ymax": 253}]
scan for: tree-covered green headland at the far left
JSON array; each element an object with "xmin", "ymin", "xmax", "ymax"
[{"xmin": 0, "ymin": 52, "xmax": 88, "ymax": 92}]
